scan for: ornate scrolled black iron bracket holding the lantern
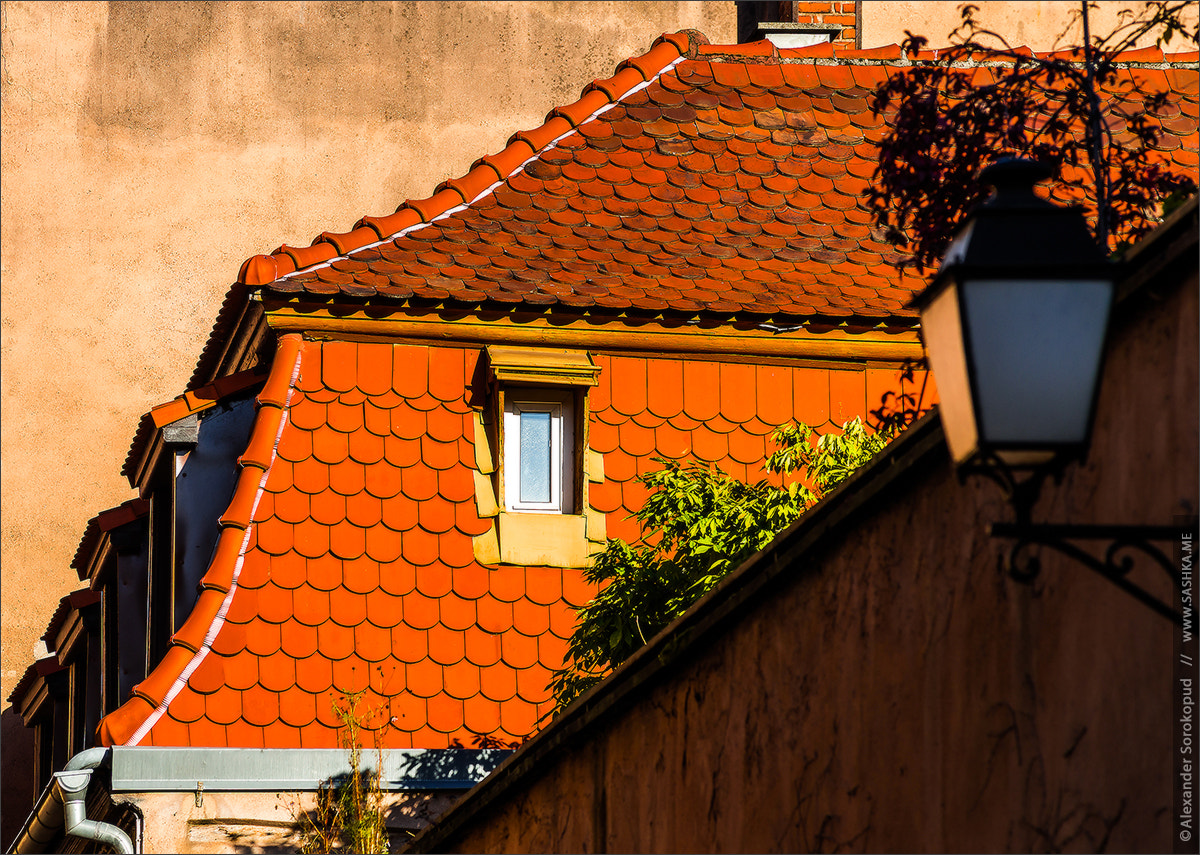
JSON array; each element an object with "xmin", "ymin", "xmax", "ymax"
[{"xmin": 959, "ymin": 456, "xmax": 1196, "ymax": 624}]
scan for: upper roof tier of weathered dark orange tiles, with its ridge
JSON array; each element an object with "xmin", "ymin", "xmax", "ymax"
[{"xmin": 234, "ymin": 31, "xmax": 1196, "ymax": 322}]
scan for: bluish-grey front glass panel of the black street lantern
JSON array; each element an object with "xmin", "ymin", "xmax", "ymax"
[{"xmin": 960, "ymin": 280, "xmax": 1112, "ymax": 448}]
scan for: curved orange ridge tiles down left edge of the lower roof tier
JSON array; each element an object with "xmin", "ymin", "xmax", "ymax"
[{"xmin": 97, "ymin": 334, "xmax": 302, "ymax": 746}]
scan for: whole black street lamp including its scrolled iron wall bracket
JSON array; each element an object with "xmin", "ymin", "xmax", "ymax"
[{"xmin": 913, "ymin": 159, "xmax": 1192, "ymax": 623}]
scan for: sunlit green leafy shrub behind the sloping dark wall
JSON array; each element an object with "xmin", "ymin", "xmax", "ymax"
[{"xmin": 551, "ymin": 417, "xmax": 916, "ymax": 710}]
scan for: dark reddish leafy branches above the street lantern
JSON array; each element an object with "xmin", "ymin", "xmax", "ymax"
[{"xmin": 868, "ymin": 2, "xmax": 1196, "ymax": 268}]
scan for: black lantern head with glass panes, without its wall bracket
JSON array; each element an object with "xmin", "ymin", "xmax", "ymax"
[{"xmin": 914, "ymin": 159, "xmax": 1115, "ymax": 467}]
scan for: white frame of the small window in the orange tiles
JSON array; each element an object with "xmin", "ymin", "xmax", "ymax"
[{"xmin": 504, "ymin": 389, "xmax": 576, "ymax": 514}]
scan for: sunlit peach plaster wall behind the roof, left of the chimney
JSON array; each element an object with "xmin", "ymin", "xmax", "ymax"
[{"xmin": 0, "ymin": 0, "xmax": 736, "ymax": 843}]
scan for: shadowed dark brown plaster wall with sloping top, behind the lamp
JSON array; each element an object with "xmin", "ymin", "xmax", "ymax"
[{"xmin": 427, "ymin": 268, "xmax": 1200, "ymax": 851}]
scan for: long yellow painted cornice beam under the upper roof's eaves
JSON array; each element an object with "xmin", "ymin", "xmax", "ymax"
[{"xmin": 266, "ymin": 305, "xmax": 923, "ymax": 361}]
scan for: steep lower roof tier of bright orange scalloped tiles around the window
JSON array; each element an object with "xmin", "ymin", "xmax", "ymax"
[{"xmin": 100, "ymin": 335, "xmax": 916, "ymax": 747}]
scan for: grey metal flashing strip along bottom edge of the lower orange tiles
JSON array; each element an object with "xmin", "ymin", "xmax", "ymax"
[{"xmin": 112, "ymin": 746, "xmax": 512, "ymax": 793}]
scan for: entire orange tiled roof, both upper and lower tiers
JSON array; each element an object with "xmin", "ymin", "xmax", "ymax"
[{"xmin": 98, "ymin": 32, "xmax": 1196, "ymax": 748}]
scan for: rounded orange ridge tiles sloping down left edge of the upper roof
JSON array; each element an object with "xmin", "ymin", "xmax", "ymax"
[{"xmin": 238, "ymin": 30, "xmax": 708, "ymax": 286}]
